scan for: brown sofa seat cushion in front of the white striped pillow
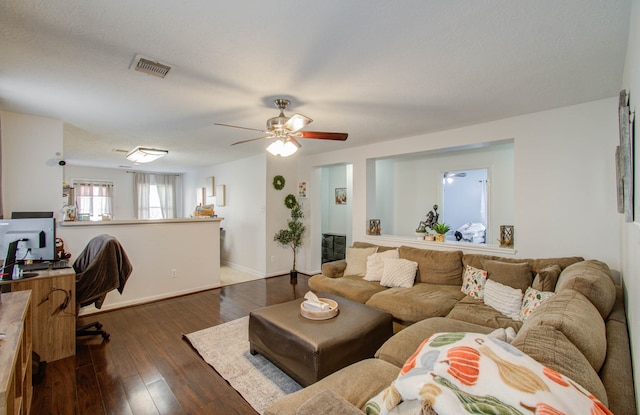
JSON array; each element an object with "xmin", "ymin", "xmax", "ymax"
[{"xmin": 366, "ymin": 284, "xmax": 464, "ymax": 322}]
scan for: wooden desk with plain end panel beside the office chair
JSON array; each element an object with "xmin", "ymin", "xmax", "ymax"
[{"xmin": 11, "ymin": 268, "xmax": 76, "ymax": 362}]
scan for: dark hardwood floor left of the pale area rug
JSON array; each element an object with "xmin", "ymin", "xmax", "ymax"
[{"xmin": 31, "ymin": 275, "xmax": 308, "ymax": 415}]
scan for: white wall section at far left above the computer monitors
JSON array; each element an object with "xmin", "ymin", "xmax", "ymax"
[{"xmin": 0, "ymin": 111, "xmax": 63, "ymax": 218}]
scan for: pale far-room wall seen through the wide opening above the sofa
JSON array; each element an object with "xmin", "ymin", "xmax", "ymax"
[{"xmin": 367, "ymin": 139, "xmax": 514, "ymax": 245}]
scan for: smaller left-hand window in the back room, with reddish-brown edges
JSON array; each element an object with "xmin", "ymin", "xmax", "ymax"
[{"xmin": 73, "ymin": 180, "xmax": 113, "ymax": 221}]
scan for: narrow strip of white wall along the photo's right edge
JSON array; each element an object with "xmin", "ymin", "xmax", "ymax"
[{"xmin": 618, "ymin": 0, "xmax": 640, "ymax": 408}]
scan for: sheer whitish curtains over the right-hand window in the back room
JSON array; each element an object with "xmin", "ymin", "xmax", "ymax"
[{"xmin": 134, "ymin": 172, "xmax": 176, "ymax": 219}]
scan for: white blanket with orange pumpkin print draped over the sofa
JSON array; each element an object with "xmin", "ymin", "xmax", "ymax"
[{"xmin": 365, "ymin": 333, "xmax": 611, "ymax": 415}]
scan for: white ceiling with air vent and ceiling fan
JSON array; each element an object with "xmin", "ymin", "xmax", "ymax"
[{"xmin": 0, "ymin": 0, "xmax": 631, "ymax": 172}]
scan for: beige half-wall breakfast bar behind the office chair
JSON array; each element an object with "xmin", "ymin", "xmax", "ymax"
[{"xmin": 56, "ymin": 218, "xmax": 223, "ymax": 314}]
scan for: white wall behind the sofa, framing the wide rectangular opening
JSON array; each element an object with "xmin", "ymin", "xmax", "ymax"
[{"xmin": 299, "ymin": 97, "xmax": 621, "ymax": 272}]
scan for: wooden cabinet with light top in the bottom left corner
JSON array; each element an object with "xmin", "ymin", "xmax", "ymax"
[{"xmin": 0, "ymin": 291, "xmax": 33, "ymax": 415}]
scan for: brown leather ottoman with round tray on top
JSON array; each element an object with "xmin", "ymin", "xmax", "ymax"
[{"xmin": 249, "ymin": 293, "xmax": 393, "ymax": 386}]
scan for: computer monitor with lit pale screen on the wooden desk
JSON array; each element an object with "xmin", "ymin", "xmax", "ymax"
[{"xmin": 0, "ymin": 218, "xmax": 56, "ymax": 263}]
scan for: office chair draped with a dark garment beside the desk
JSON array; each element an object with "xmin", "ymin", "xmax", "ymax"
[{"xmin": 73, "ymin": 234, "xmax": 133, "ymax": 340}]
